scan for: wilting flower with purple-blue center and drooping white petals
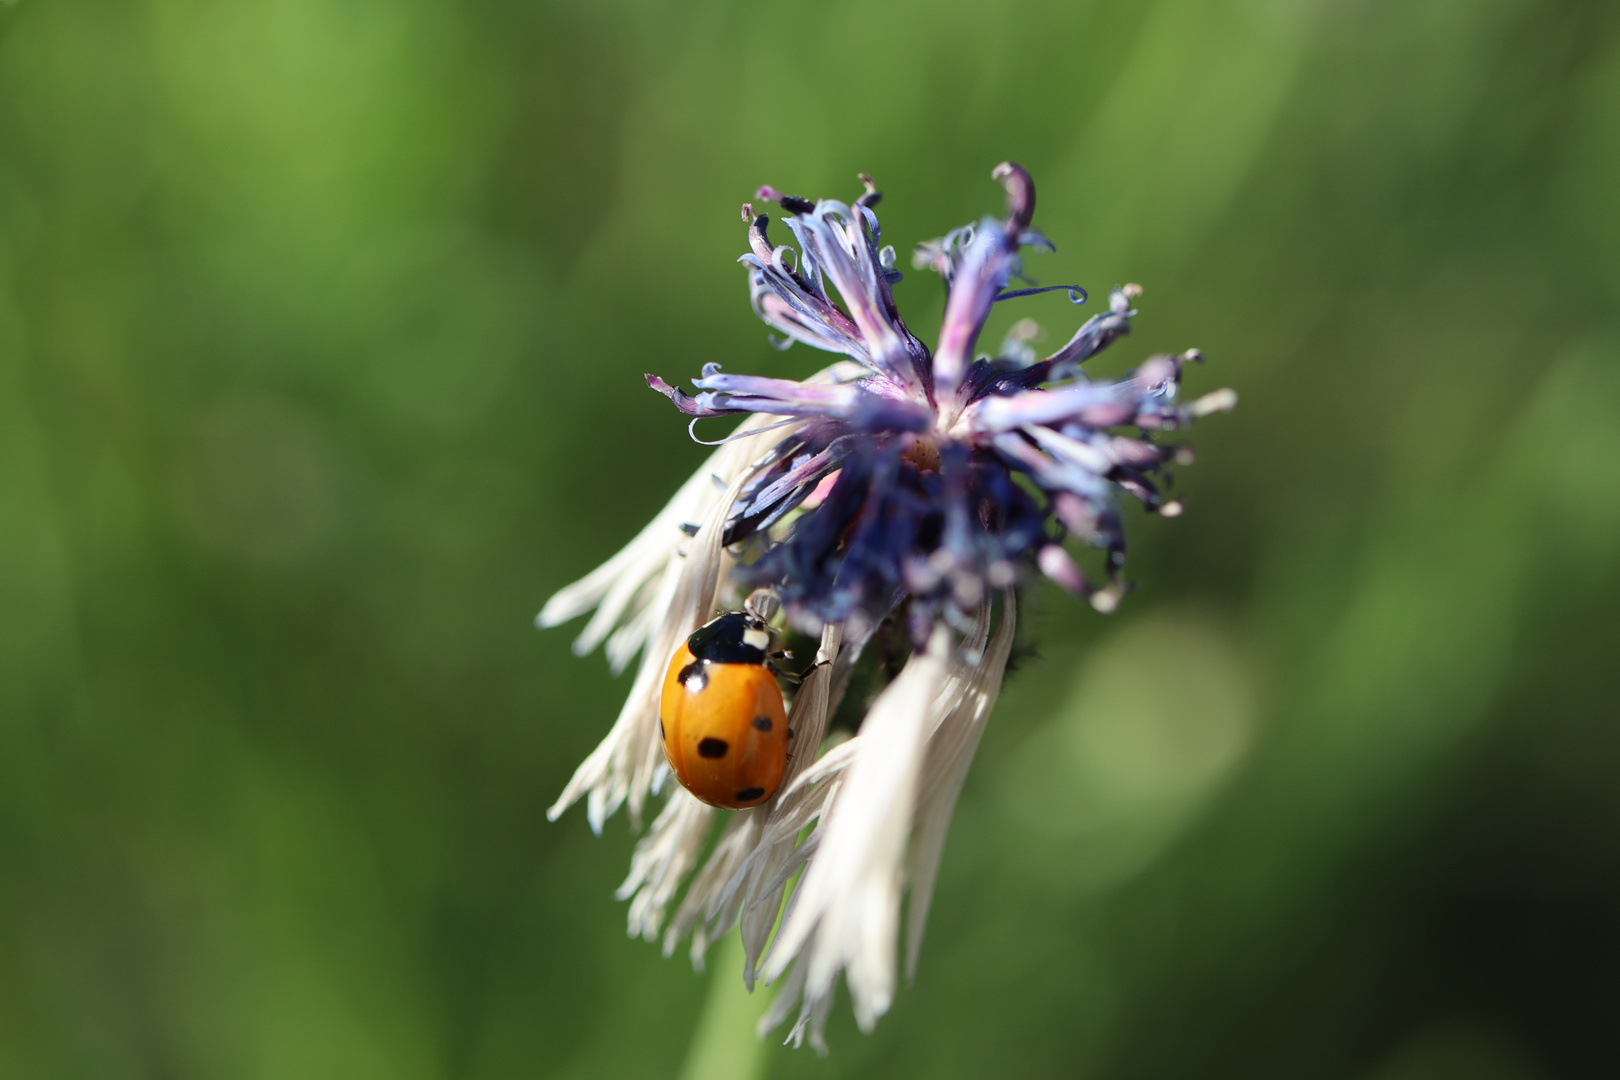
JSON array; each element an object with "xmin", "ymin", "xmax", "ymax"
[{"xmin": 538, "ymin": 164, "xmax": 1236, "ymax": 1049}]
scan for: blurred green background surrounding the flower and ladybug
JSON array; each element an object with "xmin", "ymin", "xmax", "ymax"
[{"xmin": 0, "ymin": 0, "xmax": 1620, "ymax": 1080}]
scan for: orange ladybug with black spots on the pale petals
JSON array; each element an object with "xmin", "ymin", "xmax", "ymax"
[{"xmin": 658, "ymin": 612, "xmax": 792, "ymax": 810}]
